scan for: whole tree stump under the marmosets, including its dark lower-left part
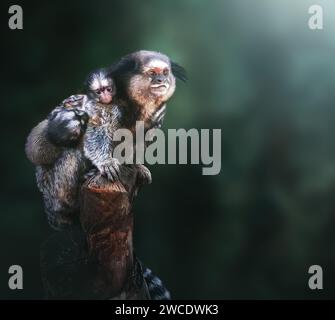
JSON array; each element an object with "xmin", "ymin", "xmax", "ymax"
[{"xmin": 41, "ymin": 167, "xmax": 150, "ymax": 299}]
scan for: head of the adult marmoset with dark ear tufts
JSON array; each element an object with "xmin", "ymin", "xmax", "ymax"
[{"xmin": 110, "ymin": 50, "xmax": 186, "ymax": 131}]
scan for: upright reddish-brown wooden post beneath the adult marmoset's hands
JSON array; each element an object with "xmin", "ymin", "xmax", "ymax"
[{"xmin": 80, "ymin": 169, "xmax": 146, "ymax": 299}]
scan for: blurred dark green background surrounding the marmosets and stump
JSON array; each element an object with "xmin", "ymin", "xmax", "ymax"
[{"xmin": 0, "ymin": 0, "xmax": 335, "ymax": 299}]
